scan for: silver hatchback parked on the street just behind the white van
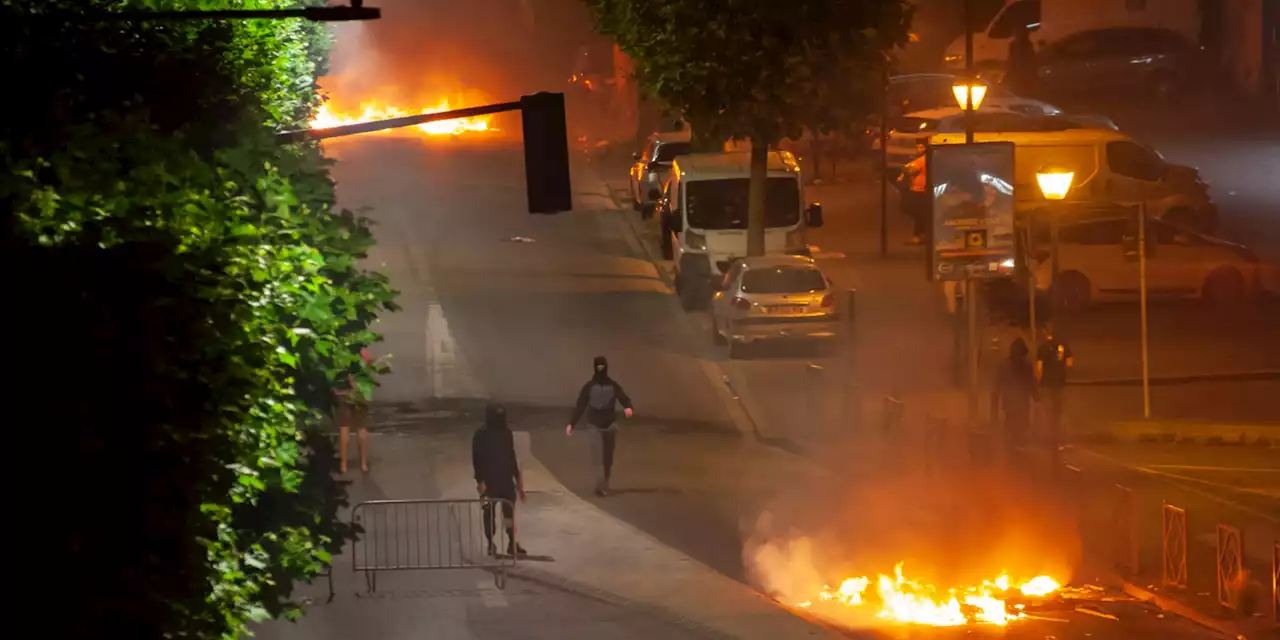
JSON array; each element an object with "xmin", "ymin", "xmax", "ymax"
[{"xmin": 712, "ymin": 255, "xmax": 841, "ymax": 357}]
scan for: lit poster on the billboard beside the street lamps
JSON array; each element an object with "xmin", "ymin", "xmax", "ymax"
[{"xmin": 924, "ymin": 142, "xmax": 1016, "ymax": 282}]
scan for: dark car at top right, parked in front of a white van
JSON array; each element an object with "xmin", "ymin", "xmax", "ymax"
[{"xmin": 1037, "ymin": 27, "xmax": 1210, "ymax": 100}]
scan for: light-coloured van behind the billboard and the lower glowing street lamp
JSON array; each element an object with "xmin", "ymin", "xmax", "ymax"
[{"xmin": 929, "ymin": 128, "xmax": 1217, "ymax": 232}]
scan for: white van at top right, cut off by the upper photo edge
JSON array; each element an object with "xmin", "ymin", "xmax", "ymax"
[{"xmin": 946, "ymin": 0, "xmax": 1201, "ymax": 76}]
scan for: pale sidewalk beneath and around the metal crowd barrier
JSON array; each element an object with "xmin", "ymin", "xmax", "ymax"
[{"xmin": 259, "ymin": 428, "xmax": 836, "ymax": 640}]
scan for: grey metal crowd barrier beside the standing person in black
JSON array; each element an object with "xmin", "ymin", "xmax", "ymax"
[{"xmin": 351, "ymin": 498, "xmax": 516, "ymax": 593}]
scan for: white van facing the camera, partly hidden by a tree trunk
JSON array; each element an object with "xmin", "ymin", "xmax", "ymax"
[{"xmin": 658, "ymin": 151, "xmax": 822, "ymax": 310}]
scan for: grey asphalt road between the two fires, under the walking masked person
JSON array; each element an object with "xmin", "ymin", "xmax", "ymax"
[{"xmin": 317, "ymin": 132, "xmax": 1218, "ymax": 637}]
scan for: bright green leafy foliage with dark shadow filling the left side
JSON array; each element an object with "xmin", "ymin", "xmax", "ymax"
[{"xmin": 0, "ymin": 0, "xmax": 394, "ymax": 639}]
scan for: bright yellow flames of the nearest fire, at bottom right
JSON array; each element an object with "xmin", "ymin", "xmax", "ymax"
[{"xmin": 796, "ymin": 563, "xmax": 1061, "ymax": 627}]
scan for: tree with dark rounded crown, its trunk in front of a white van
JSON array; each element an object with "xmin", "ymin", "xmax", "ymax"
[{"xmin": 588, "ymin": 0, "xmax": 911, "ymax": 256}]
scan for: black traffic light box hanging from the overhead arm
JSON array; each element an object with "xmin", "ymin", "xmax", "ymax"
[{"xmin": 520, "ymin": 92, "xmax": 573, "ymax": 214}]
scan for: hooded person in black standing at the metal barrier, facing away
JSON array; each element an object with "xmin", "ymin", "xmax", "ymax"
[{"xmin": 471, "ymin": 402, "xmax": 526, "ymax": 556}]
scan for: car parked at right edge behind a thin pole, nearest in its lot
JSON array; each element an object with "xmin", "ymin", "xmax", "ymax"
[{"xmin": 1036, "ymin": 216, "xmax": 1276, "ymax": 310}]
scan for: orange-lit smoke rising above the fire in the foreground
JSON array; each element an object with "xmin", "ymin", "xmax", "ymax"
[{"xmin": 742, "ymin": 442, "xmax": 1080, "ymax": 626}]
